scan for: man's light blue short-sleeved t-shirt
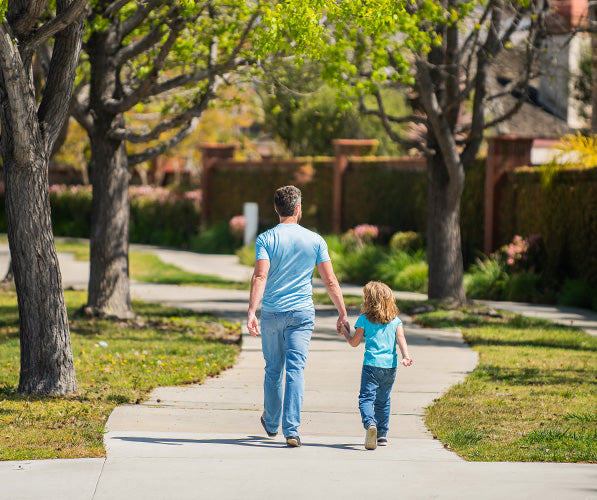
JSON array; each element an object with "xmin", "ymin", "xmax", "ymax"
[{"xmin": 255, "ymin": 224, "xmax": 330, "ymax": 312}]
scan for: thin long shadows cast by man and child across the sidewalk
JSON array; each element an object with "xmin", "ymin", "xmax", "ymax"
[{"xmin": 111, "ymin": 436, "xmax": 363, "ymax": 451}]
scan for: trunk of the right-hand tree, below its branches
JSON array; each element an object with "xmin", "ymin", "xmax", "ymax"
[{"xmin": 427, "ymin": 154, "xmax": 466, "ymax": 304}]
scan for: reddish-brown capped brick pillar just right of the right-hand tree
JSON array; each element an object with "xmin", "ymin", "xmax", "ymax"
[{"xmin": 483, "ymin": 136, "xmax": 533, "ymax": 255}]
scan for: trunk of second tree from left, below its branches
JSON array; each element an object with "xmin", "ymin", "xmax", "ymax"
[{"xmin": 87, "ymin": 126, "xmax": 133, "ymax": 318}]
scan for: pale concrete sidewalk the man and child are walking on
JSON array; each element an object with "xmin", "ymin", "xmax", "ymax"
[{"xmin": 0, "ymin": 244, "xmax": 597, "ymax": 500}]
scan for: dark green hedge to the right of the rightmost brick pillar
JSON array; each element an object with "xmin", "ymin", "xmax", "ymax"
[{"xmin": 498, "ymin": 168, "xmax": 597, "ymax": 286}]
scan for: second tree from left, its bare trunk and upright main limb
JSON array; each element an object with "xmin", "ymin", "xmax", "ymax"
[{"xmin": 86, "ymin": 30, "xmax": 133, "ymax": 318}]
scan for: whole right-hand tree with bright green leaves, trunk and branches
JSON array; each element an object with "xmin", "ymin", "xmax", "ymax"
[{"xmin": 264, "ymin": 0, "xmax": 549, "ymax": 302}]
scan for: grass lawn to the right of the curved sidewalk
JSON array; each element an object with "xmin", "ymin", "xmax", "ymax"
[{"xmin": 415, "ymin": 307, "xmax": 597, "ymax": 462}]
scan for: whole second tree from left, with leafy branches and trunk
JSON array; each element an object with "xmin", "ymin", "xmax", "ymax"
[{"xmin": 72, "ymin": 0, "xmax": 258, "ymax": 317}]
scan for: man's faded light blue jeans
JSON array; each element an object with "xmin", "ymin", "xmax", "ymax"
[{"xmin": 261, "ymin": 309, "xmax": 315, "ymax": 437}]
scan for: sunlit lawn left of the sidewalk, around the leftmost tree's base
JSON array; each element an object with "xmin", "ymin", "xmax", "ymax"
[{"xmin": 0, "ymin": 290, "xmax": 240, "ymax": 460}]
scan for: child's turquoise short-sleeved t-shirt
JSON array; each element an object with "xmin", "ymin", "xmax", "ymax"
[{"xmin": 354, "ymin": 314, "xmax": 402, "ymax": 368}]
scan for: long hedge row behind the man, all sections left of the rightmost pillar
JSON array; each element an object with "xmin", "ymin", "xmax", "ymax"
[{"xmin": 0, "ymin": 158, "xmax": 485, "ymax": 262}]
